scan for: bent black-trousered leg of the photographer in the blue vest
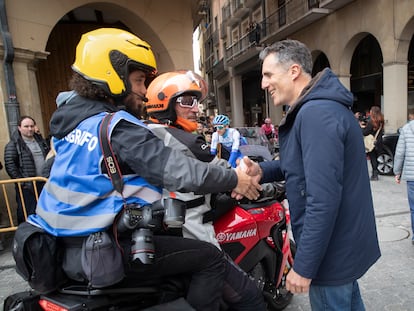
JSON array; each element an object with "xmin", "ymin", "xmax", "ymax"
[{"xmin": 125, "ymin": 235, "xmax": 226, "ymax": 311}]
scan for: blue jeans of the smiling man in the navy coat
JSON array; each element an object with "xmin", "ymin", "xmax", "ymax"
[{"xmin": 309, "ymin": 281, "xmax": 365, "ymax": 311}]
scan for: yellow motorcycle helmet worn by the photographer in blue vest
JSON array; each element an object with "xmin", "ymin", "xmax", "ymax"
[{"xmin": 72, "ymin": 28, "xmax": 157, "ymax": 97}]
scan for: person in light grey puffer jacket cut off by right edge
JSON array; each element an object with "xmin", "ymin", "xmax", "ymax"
[{"xmin": 394, "ymin": 109, "xmax": 414, "ymax": 245}]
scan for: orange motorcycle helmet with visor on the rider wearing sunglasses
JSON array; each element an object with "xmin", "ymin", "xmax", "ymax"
[{"xmin": 145, "ymin": 70, "xmax": 208, "ymax": 123}]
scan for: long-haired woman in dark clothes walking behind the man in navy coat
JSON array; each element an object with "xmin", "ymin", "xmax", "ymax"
[{"xmin": 362, "ymin": 106, "xmax": 384, "ymax": 180}]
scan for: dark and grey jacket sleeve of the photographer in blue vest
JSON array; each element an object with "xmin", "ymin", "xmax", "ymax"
[{"xmin": 111, "ymin": 120, "xmax": 237, "ymax": 194}]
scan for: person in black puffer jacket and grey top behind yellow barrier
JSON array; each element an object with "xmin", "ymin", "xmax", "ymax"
[{"xmin": 4, "ymin": 116, "xmax": 49, "ymax": 223}]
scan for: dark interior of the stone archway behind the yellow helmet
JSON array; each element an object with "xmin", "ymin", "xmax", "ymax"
[{"xmin": 32, "ymin": 3, "xmax": 174, "ymax": 135}]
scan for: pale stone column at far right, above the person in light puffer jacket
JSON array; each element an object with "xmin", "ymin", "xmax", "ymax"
[{"xmin": 383, "ymin": 61, "xmax": 408, "ymax": 133}]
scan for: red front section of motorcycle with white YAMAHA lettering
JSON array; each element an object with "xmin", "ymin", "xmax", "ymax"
[{"xmin": 214, "ymin": 183, "xmax": 296, "ymax": 311}]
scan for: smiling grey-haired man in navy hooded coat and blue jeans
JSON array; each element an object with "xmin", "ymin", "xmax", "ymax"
[{"xmin": 241, "ymin": 40, "xmax": 380, "ymax": 310}]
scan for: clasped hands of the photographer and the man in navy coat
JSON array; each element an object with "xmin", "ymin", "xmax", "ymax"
[{"xmin": 231, "ymin": 156, "xmax": 263, "ymax": 200}]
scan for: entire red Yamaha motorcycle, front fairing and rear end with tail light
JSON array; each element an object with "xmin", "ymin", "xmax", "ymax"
[{"xmin": 4, "ymin": 188, "xmax": 295, "ymax": 311}]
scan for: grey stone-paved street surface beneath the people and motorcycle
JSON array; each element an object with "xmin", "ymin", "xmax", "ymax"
[{"xmin": 0, "ymin": 165, "xmax": 414, "ymax": 311}]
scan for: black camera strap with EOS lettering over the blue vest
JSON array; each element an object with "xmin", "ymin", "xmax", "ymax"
[{"xmin": 99, "ymin": 113, "xmax": 124, "ymax": 198}]
